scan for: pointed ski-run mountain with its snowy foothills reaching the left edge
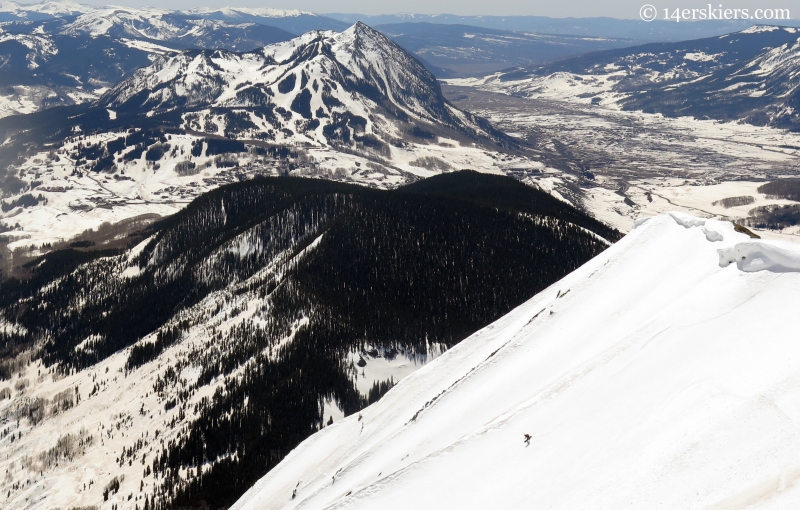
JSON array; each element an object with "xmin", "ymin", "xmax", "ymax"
[{"xmin": 0, "ymin": 24, "xmax": 544, "ymax": 262}]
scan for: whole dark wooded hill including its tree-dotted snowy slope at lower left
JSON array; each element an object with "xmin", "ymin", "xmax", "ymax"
[{"xmin": 0, "ymin": 173, "xmax": 615, "ymax": 510}]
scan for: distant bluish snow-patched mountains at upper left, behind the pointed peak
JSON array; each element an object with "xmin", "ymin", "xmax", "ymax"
[{"xmin": 0, "ymin": 7, "xmax": 294, "ymax": 117}]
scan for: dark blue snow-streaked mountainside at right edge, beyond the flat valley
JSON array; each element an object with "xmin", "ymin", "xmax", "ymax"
[{"xmin": 462, "ymin": 26, "xmax": 800, "ymax": 130}]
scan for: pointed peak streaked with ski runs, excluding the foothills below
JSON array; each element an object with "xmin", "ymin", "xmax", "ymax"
[{"xmin": 97, "ymin": 23, "xmax": 510, "ymax": 147}]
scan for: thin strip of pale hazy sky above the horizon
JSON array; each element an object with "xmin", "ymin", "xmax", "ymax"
[{"xmin": 78, "ymin": 0, "xmax": 800, "ymax": 20}]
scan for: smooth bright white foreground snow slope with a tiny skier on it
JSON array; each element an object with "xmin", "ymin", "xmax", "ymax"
[{"xmin": 233, "ymin": 213, "xmax": 800, "ymax": 510}]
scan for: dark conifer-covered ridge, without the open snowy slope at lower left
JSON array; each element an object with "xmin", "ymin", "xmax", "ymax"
[{"xmin": 0, "ymin": 172, "xmax": 619, "ymax": 510}]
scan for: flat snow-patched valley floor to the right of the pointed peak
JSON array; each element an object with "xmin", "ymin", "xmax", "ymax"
[{"xmin": 443, "ymin": 85, "xmax": 800, "ymax": 242}]
